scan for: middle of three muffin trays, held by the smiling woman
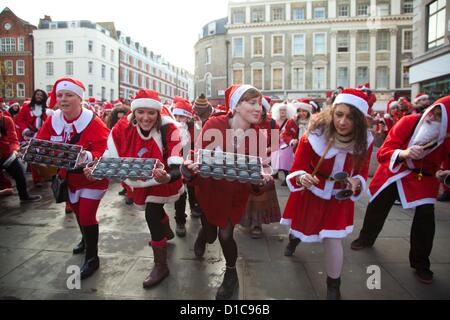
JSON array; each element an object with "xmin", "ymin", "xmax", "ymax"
[{"xmin": 92, "ymin": 157, "xmax": 160, "ymax": 180}]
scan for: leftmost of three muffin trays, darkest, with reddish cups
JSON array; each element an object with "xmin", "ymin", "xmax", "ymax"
[{"xmin": 22, "ymin": 138, "xmax": 83, "ymax": 170}]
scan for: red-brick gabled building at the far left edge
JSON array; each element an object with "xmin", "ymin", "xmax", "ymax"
[{"xmin": 0, "ymin": 8, "xmax": 36, "ymax": 102}]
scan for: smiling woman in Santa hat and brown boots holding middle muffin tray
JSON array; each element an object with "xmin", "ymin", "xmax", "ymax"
[{"xmin": 98, "ymin": 90, "xmax": 184, "ymax": 288}]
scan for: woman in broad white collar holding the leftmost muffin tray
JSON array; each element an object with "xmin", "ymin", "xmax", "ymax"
[{"xmin": 36, "ymin": 78, "xmax": 109, "ymax": 279}]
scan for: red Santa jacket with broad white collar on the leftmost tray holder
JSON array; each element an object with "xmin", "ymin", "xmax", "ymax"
[{"xmin": 36, "ymin": 108, "xmax": 109, "ymax": 192}]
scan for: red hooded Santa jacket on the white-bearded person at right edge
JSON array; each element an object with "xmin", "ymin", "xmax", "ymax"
[{"xmin": 369, "ymin": 100, "xmax": 450, "ymax": 209}]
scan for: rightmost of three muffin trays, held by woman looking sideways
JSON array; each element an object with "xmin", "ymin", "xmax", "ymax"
[{"xmin": 197, "ymin": 149, "xmax": 264, "ymax": 184}]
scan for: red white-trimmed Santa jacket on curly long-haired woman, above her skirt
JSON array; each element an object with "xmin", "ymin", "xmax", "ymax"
[{"xmin": 286, "ymin": 132, "xmax": 373, "ymax": 201}]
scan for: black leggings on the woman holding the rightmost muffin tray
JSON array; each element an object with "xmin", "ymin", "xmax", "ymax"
[{"xmin": 199, "ymin": 215, "xmax": 237, "ymax": 268}]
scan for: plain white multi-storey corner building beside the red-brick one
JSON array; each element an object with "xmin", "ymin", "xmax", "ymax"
[{"xmin": 33, "ymin": 19, "xmax": 119, "ymax": 101}]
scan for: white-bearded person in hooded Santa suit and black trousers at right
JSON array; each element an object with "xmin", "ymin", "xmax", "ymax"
[{"xmin": 352, "ymin": 96, "xmax": 450, "ymax": 283}]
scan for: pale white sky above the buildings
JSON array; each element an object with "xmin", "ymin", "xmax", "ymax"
[{"xmin": 0, "ymin": 0, "xmax": 228, "ymax": 74}]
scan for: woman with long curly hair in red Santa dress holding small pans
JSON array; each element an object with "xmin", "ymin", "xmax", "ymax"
[{"xmin": 281, "ymin": 89, "xmax": 373, "ymax": 299}]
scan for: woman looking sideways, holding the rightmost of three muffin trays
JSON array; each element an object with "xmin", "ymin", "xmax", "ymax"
[{"xmin": 182, "ymin": 85, "xmax": 272, "ymax": 299}]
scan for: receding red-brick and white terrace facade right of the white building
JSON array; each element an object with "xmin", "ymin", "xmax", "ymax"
[{"xmin": 117, "ymin": 31, "xmax": 193, "ymax": 101}]
